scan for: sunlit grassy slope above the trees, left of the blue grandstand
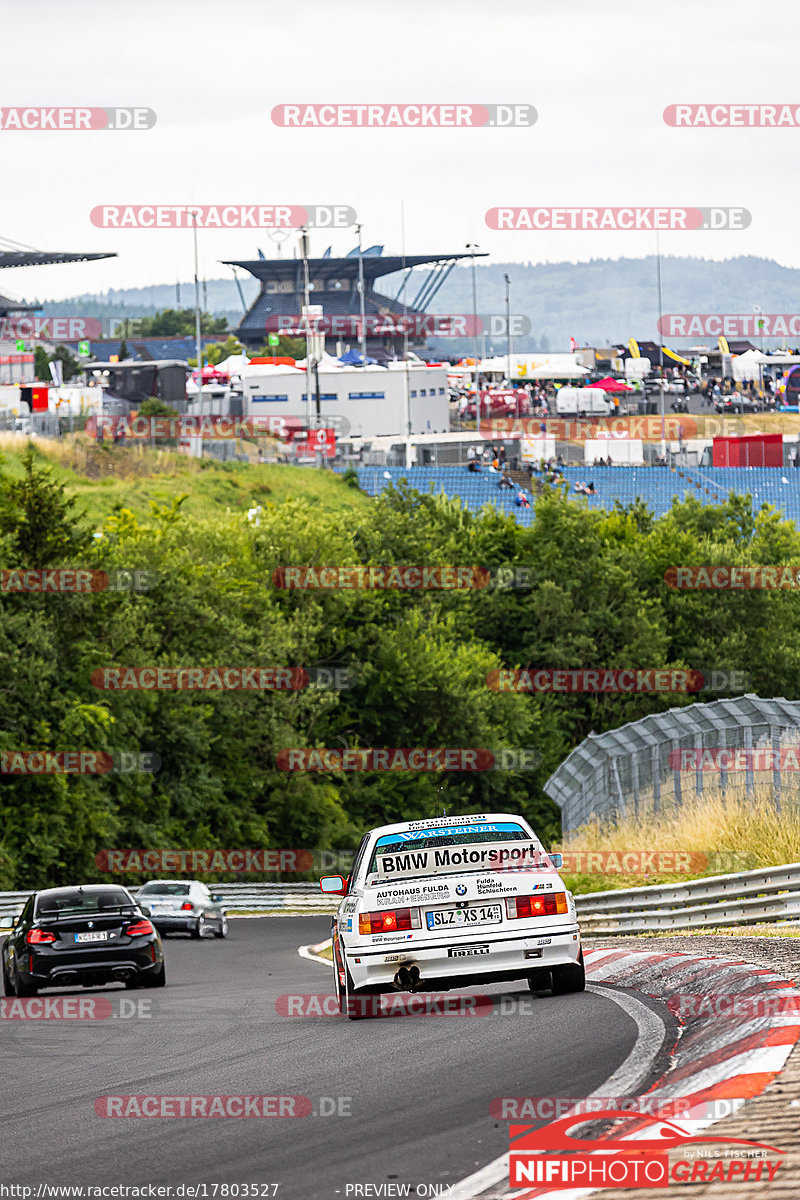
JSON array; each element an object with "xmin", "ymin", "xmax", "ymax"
[{"xmin": 0, "ymin": 438, "xmax": 369, "ymax": 522}]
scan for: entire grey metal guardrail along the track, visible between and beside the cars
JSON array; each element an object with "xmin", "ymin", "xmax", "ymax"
[{"xmin": 0, "ymin": 863, "xmax": 800, "ymax": 936}]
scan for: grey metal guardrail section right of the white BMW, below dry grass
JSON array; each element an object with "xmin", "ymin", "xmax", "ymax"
[{"xmin": 575, "ymin": 863, "xmax": 800, "ymax": 936}]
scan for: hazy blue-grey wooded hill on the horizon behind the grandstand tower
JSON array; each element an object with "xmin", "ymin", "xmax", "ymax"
[{"xmin": 29, "ymin": 256, "xmax": 800, "ymax": 354}]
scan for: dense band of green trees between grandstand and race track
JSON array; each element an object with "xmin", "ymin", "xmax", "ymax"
[{"xmin": 0, "ymin": 458, "xmax": 800, "ymax": 887}]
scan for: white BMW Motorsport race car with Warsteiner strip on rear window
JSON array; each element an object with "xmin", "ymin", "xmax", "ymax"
[{"xmin": 320, "ymin": 812, "xmax": 585, "ymax": 1018}]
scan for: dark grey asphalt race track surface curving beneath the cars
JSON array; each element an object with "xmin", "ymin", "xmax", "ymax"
[{"xmin": 0, "ymin": 917, "xmax": 671, "ymax": 1200}]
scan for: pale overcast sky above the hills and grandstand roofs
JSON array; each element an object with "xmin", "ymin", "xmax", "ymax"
[{"xmin": 0, "ymin": 0, "xmax": 800, "ymax": 298}]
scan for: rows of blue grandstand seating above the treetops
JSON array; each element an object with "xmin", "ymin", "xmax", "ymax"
[{"xmin": 347, "ymin": 466, "xmax": 800, "ymax": 524}]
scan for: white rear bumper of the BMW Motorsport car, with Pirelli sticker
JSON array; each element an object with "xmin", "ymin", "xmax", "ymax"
[{"xmin": 345, "ymin": 925, "xmax": 581, "ymax": 989}]
